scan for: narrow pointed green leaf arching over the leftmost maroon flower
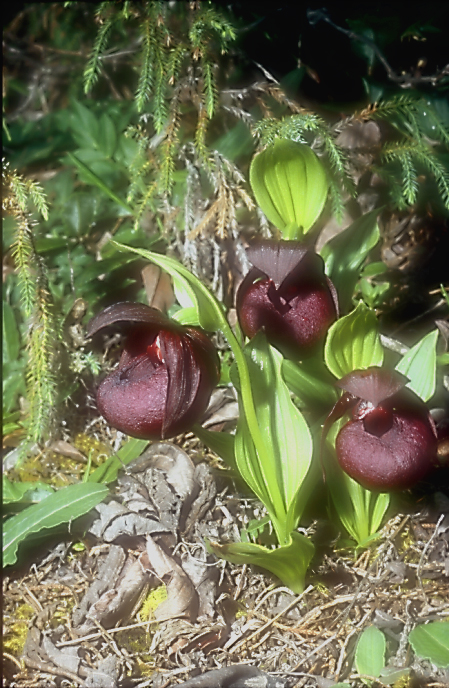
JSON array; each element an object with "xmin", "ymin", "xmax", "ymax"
[{"xmin": 113, "ymin": 241, "xmax": 227, "ymax": 332}]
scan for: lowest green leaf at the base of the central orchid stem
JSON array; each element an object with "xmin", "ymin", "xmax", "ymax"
[{"xmin": 207, "ymin": 532, "xmax": 315, "ymax": 594}]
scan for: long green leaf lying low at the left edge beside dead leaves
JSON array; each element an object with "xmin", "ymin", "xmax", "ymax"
[{"xmin": 3, "ymin": 483, "xmax": 108, "ymax": 566}]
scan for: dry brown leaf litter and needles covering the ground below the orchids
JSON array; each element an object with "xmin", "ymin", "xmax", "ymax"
[{"xmin": 3, "ymin": 430, "xmax": 449, "ymax": 688}]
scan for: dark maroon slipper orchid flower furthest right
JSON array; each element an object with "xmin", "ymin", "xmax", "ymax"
[{"xmin": 324, "ymin": 368, "xmax": 437, "ymax": 492}]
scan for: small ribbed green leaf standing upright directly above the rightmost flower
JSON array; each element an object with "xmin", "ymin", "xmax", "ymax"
[{"xmin": 324, "ymin": 301, "xmax": 384, "ymax": 379}]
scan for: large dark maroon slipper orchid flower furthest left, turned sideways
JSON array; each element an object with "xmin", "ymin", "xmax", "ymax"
[{"xmin": 88, "ymin": 303, "xmax": 220, "ymax": 439}]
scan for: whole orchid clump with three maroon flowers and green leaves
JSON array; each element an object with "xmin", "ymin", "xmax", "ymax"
[{"xmin": 89, "ymin": 140, "xmax": 436, "ymax": 592}]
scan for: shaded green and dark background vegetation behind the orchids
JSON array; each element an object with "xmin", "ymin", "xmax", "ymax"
[{"xmin": 3, "ymin": 2, "xmax": 449, "ymax": 448}]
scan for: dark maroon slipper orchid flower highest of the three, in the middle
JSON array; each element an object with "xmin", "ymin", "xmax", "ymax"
[{"xmin": 237, "ymin": 241, "xmax": 338, "ymax": 358}]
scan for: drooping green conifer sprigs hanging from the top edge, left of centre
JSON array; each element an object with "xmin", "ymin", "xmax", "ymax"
[{"xmin": 84, "ymin": 0, "xmax": 236, "ymax": 202}]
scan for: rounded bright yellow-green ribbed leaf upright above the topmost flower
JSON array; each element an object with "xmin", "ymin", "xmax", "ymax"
[{"xmin": 249, "ymin": 139, "xmax": 329, "ymax": 239}]
